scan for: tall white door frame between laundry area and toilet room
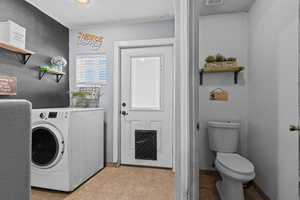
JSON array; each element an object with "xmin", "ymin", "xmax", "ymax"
[{"xmin": 173, "ymin": 0, "xmax": 201, "ymax": 200}]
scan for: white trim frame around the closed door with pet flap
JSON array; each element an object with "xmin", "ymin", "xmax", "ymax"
[{"xmin": 113, "ymin": 38, "xmax": 176, "ymax": 170}]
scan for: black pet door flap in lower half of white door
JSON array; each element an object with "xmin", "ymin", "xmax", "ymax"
[{"xmin": 135, "ymin": 130, "xmax": 157, "ymax": 160}]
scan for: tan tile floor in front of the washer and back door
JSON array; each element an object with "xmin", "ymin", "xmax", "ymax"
[{"xmin": 32, "ymin": 166, "xmax": 175, "ymax": 200}]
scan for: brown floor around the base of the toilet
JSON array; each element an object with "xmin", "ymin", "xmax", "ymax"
[{"xmin": 200, "ymin": 171, "xmax": 269, "ymax": 200}]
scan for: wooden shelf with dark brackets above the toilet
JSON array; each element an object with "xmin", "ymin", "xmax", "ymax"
[{"xmin": 200, "ymin": 67, "xmax": 245, "ymax": 85}]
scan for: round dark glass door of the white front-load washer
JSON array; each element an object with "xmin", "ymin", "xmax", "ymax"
[{"xmin": 32, "ymin": 124, "xmax": 64, "ymax": 169}]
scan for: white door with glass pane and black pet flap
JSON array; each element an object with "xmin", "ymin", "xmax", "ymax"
[{"xmin": 120, "ymin": 46, "xmax": 174, "ymax": 168}]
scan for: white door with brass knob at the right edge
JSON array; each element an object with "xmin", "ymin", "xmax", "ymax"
[{"xmin": 274, "ymin": 0, "xmax": 300, "ymax": 200}]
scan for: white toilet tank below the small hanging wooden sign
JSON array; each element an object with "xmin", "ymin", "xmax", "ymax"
[{"xmin": 207, "ymin": 121, "xmax": 240, "ymax": 153}]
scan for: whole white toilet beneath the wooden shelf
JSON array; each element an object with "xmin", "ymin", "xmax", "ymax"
[{"xmin": 208, "ymin": 121, "xmax": 255, "ymax": 200}]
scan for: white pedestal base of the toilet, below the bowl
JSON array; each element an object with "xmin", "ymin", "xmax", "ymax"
[{"xmin": 216, "ymin": 176, "xmax": 245, "ymax": 200}]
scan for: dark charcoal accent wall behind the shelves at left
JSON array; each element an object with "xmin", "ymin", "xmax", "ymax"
[{"xmin": 0, "ymin": 0, "xmax": 69, "ymax": 108}]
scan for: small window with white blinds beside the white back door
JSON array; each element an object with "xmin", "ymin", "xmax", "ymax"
[{"xmin": 76, "ymin": 54, "xmax": 107, "ymax": 86}]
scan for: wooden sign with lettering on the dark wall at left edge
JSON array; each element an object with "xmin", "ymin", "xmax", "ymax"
[{"xmin": 0, "ymin": 75, "xmax": 17, "ymax": 95}]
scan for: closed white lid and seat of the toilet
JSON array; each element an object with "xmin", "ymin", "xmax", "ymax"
[{"xmin": 217, "ymin": 153, "xmax": 254, "ymax": 174}]
